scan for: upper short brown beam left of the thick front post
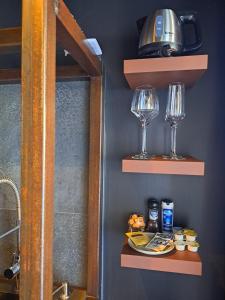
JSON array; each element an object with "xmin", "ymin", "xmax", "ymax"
[{"xmin": 0, "ymin": 27, "xmax": 22, "ymax": 54}]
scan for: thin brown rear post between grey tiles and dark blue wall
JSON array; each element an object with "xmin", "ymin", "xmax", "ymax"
[{"xmin": 87, "ymin": 77, "xmax": 102, "ymax": 298}]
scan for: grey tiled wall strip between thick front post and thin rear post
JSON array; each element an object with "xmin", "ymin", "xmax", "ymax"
[{"xmin": 54, "ymin": 81, "xmax": 89, "ymax": 287}]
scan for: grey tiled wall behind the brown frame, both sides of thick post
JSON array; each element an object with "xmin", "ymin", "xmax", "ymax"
[{"xmin": 0, "ymin": 81, "xmax": 89, "ymax": 286}]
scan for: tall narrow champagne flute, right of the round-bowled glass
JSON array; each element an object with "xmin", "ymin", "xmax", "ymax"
[{"xmin": 165, "ymin": 82, "xmax": 185, "ymax": 160}]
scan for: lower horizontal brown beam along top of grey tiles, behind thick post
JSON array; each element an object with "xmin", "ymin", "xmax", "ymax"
[{"xmin": 0, "ymin": 65, "xmax": 89, "ymax": 84}]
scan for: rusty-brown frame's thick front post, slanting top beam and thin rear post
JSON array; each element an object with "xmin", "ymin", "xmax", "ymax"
[{"xmin": 19, "ymin": 0, "xmax": 102, "ymax": 300}]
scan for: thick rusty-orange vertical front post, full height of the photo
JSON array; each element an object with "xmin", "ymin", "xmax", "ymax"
[{"xmin": 20, "ymin": 0, "xmax": 56, "ymax": 300}]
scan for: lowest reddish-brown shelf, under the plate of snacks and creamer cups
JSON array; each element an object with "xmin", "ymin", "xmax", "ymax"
[{"xmin": 121, "ymin": 244, "xmax": 202, "ymax": 276}]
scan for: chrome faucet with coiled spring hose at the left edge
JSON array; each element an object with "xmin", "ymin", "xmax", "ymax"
[{"xmin": 0, "ymin": 177, "xmax": 21, "ymax": 279}]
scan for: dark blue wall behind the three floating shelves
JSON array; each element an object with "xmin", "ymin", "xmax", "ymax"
[{"xmin": 67, "ymin": 0, "xmax": 225, "ymax": 300}]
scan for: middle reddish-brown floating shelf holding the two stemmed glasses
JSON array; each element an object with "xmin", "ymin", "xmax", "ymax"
[{"xmin": 122, "ymin": 156, "xmax": 205, "ymax": 176}]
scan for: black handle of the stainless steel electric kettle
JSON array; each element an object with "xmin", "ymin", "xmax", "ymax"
[{"xmin": 179, "ymin": 13, "xmax": 202, "ymax": 53}]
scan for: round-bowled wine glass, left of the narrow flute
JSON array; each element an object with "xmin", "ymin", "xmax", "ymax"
[{"xmin": 131, "ymin": 86, "xmax": 159, "ymax": 159}]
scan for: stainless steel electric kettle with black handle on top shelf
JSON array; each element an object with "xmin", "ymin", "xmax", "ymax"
[{"xmin": 137, "ymin": 9, "xmax": 202, "ymax": 57}]
